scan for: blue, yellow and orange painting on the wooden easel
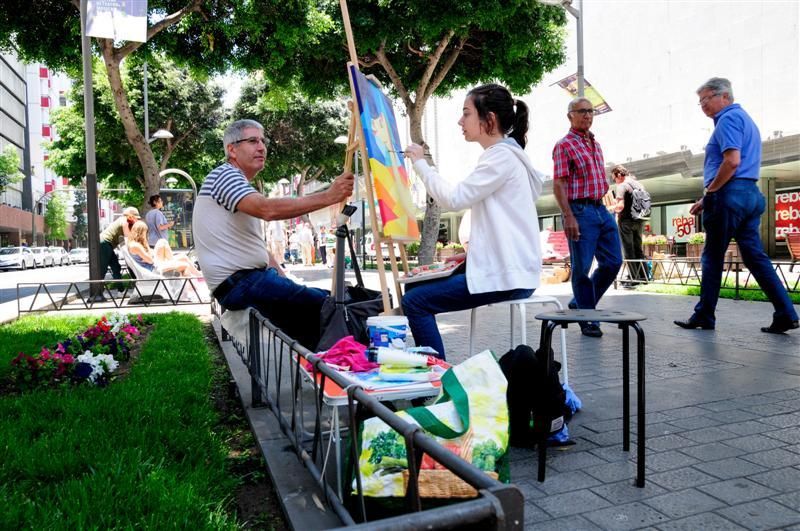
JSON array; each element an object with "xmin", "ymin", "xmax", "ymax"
[{"xmin": 350, "ymin": 65, "xmax": 419, "ymax": 241}]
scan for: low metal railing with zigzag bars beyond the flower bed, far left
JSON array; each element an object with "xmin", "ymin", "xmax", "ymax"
[{"xmin": 17, "ymin": 277, "xmax": 211, "ymax": 315}]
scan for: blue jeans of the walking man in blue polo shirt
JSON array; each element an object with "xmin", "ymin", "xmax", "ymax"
[{"xmin": 694, "ymin": 179, "xmax": 797, "ymax": 325}]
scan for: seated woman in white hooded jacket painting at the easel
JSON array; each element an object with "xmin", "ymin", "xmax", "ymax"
[{"xmin": 402, "ymin": 84, "xmax": 542, "ymax": 358}]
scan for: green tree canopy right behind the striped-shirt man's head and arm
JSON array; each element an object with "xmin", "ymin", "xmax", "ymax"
[{"xmin": 233, "ymin": 75, "xmax": 348, "ymax": 195}]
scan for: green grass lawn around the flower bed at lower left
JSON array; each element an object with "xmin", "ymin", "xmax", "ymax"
[{"xmin": 0, "ymin": 313, "xmax": 283, "ymax": 529}]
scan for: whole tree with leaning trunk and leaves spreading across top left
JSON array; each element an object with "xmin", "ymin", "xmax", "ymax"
[{"xmin": 0, "ymin": 0, "xmax": 331, "ymax": 206}]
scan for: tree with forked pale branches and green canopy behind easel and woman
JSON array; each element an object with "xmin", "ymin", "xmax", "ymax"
[{"xmin": 282, "ymin": 0, "xmax": 566, "ymax": 263}]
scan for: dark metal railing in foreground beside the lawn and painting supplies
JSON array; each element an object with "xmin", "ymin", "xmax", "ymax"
[{"xmin": 212, "ymin": 302, "xmax": 524, "ymax": 530}]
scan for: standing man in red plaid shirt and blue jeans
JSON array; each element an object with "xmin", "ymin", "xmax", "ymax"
[{"xmin": 553, "ymin": 98, "xmax": 622, "ymax": 337}]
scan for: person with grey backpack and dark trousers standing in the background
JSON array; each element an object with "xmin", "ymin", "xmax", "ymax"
[{"xmin": 611, "ymin": 164, "xmax": 650, "ymax": 289}]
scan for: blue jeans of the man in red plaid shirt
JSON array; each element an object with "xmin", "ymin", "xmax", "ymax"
[{"xmin": 569, "ymin": 203, "xmax": 622, "ymax": 310}]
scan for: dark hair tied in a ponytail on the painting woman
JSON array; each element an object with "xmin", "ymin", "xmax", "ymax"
[{"xmin": 467, "ymin": 83, "xmax": 528, "ymax": 148}]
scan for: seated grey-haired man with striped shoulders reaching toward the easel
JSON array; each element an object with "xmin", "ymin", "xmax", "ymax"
[{"xmin": 192, "ymin": 120, "xmax": 354, "ymax": 349}]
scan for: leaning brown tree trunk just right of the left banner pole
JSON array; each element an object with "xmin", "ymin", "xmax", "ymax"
[{"xmin": 98, "ymin": 39, "xmax": 161, "ymax": 208}]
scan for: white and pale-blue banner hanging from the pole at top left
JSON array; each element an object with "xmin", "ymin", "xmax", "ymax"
[{"xmin": 86, "ymin": 0, "xmax": 147, "ymax": 42}]
